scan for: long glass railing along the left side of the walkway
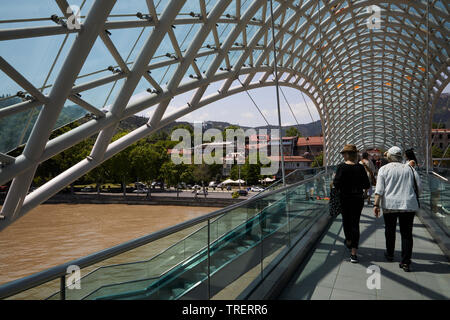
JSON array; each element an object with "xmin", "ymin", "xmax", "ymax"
[{"xmin": 0, "ymin": 170, "xmax": 332, "ymax": 300}]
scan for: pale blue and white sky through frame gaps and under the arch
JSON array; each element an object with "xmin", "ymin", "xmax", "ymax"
[{"xmin": 0, "ymin": 0, "xmax": 450, "ymax": 131}]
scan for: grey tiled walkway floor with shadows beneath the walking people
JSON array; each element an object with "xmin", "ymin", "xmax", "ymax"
[{"xmin": 280, "ymin": 207, "xmax": 450, "ymax": 300}]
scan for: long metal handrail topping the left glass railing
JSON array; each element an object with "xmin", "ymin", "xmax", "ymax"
[{"xmin": 0, "ymin": 171, "xmax": 324, "ymax": 299}]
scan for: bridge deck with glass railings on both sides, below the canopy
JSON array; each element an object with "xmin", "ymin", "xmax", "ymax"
[{"xmin": 0, "ymin": 167, "xmax": 450, "ymax": 300}]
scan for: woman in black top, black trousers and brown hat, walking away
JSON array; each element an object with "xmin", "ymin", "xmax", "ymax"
[{"xmin": 333, "ymin": 144, "xmax": 370, "ymax": 263}]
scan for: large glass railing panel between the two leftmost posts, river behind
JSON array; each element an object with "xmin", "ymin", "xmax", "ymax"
[{"xmin": 46, "ymin": 223, "xmax": 207, "ymax": 300}]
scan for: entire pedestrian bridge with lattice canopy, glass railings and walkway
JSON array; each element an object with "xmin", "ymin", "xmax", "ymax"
[{"xmin": 0, "ymin": 0, "xmax": 450, "ymax": 299}]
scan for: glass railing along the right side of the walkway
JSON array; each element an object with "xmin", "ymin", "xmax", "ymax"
[{"xmin": 420, "ymin": 170, "xmax": 450, "ymax": 236}]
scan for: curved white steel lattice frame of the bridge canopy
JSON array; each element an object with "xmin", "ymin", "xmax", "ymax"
[{"xmin": 0, "ymin": 0, "xmax": 450, "ymax": 230}]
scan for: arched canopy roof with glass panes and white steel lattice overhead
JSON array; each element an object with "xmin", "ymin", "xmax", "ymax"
[{"xmin": 0, "ymin": 0, "xmax": 450, "ymax": 222}]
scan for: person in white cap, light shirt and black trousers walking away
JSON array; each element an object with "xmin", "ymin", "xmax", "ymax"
[{"xmin": 373, "ymin": 146, "xmax": 422, "ymax": 272}]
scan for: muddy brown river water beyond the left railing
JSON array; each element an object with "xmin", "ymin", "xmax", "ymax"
[{"xmin": 0, "ymin": 204, "xmax": 219, "ymax": 298}]
